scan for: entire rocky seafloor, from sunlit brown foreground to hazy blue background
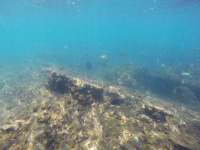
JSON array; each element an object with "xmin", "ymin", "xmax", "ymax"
[{"xmin": 0, "ymin": 57, "xmax": 200, "ymax": 150}]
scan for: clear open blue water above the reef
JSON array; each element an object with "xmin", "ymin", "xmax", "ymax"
[{"xmin": 0, "ymin": 0, "xmax": 200, "ymax": 69}]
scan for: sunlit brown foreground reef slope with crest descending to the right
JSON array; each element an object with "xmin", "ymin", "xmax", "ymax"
[{"xmin": 0, "ymin": 69, "xmax": 200, "ymax": 150}]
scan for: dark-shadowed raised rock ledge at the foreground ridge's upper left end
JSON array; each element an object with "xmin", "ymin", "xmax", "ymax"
[{"xmin": 47, "ymin": 70, "xmax": 104, "ymax": 105}]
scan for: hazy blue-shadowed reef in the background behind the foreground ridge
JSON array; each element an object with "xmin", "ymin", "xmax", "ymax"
[{"xmin": 104, "ymin": 63, "xmax": 200, "ymax": 110}]
